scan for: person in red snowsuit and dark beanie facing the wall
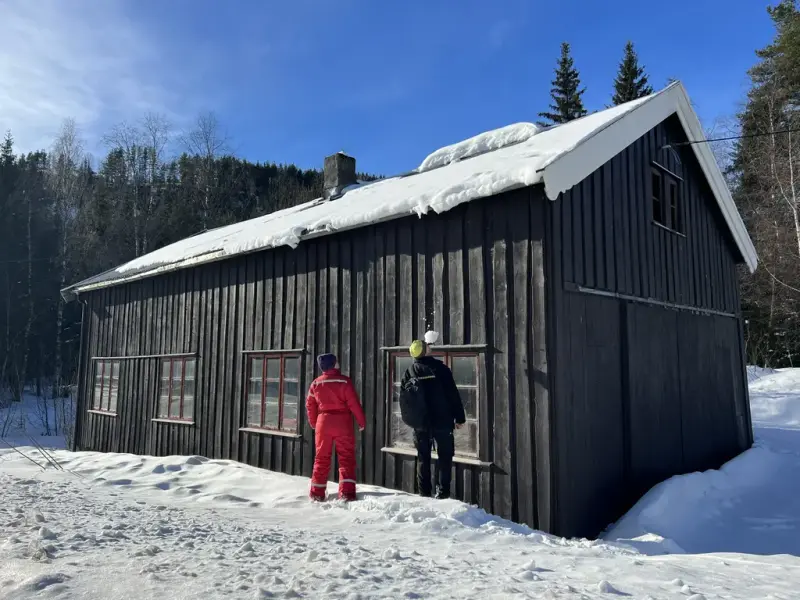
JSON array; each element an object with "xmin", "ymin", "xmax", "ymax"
[{"xmin": 306, "ymin": 354, "xmax": 367, "ymax": 501}]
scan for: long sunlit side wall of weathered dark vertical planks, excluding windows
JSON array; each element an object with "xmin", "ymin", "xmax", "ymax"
[{"xmin": 78, "ymin": 188, "xmax": 549, "ymax": 526}]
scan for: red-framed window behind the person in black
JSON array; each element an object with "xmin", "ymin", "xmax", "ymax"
[{"xmin": 389, "ymin": 351, "xmax": 480, "ymax": 457}]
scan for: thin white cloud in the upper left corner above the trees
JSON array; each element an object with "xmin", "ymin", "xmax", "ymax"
[{"xmin": 0, "ymin": 0, "xmax": 198, "ymax": 157}]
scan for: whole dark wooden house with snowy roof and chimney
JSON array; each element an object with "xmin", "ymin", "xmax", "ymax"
[{"xmin": 64, "ymin": 84, "xmax": 756, "ymax": 536}]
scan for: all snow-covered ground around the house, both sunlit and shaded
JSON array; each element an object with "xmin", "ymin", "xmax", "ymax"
[{"xmin": 0, "ymin": 371, "xmax": 800, "ymax": 600}]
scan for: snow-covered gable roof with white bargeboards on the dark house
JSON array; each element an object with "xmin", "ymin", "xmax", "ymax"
[{"xmin": 62, "ymin": 82, "xmax": 757, "ymax": 298}]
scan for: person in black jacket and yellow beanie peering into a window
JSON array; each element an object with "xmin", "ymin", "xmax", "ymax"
[{"xmin": 401, "ymin": 340, "xmax": 466, "ymax": 499}]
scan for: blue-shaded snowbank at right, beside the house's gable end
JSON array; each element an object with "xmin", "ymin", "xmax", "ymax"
[{"xmin": 604, "ymin": 369, "xmax": 800, "ymax": 556}]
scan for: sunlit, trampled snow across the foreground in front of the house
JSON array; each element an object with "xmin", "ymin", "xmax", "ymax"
[{"xmin": 0, "ymin": 448, "xmax": 800, "ymax": 600}]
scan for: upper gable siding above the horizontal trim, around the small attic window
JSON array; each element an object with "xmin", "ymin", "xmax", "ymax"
[{"xmin": 552, "ymin": 118, "xmax": 738, "ymax": 314}]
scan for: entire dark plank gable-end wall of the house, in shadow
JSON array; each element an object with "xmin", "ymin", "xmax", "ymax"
[{"xmin": 546, "ymin": 118, "xmax": 752, "ymax": 536}]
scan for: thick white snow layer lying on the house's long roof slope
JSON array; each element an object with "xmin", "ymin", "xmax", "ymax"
[{"xmin": 70, "ymin": 92, "xmax": 665, "ymax": 289}]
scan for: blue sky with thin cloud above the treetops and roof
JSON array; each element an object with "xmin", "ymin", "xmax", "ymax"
[{"xmin": 0, "ymin": 0, "xmax": 773, "ymax": 174}]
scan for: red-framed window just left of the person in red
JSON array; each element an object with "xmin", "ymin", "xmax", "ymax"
[{"xmin": 246, "ymin": 354, "xmax": 300, "ymax": 433}]
